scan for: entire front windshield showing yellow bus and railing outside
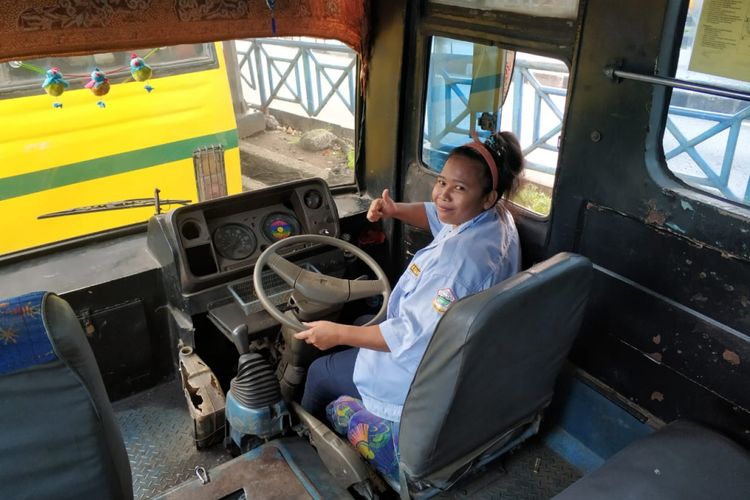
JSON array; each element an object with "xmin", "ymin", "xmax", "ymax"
[{"xmin": 0, "ymin": 38, "xmax": 357, "ymax": 255}]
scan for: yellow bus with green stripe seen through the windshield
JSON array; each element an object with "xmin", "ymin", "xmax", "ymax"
[{"xmin": 0, "ymin": 43, "xmax": 242, "ymax": 255}]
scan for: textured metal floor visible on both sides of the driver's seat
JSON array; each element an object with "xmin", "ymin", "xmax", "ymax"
[{"xmin": 113, "ymin": 381, "xmax": 581, "ymax": 500}]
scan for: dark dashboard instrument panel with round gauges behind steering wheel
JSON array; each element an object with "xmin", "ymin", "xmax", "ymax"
[{"xmin": 156, "ymin": 179, "xmax": 339, "ymax": 292}]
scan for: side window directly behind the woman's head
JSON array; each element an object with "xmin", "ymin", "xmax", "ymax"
[{"xmin": 422, "ymin": 36, "xmax": 568, "ymax": 215}]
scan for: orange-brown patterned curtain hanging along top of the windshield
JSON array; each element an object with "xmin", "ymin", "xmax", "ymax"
[{"xmin": 0, "ymin": 0, "xmax": 367, "ymax": 61}]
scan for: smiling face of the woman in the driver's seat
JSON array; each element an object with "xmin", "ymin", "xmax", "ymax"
[{"xmin": 432, "ymin": 155, "xmax": 497, "ymax": 226}]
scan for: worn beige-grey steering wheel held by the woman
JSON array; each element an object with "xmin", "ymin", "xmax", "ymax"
[{"xmin": 253, "ymin": 234, "xmax": 391, "ymax": 332}]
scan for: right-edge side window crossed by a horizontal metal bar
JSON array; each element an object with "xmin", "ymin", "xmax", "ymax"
[{"xmin": 663, "ymin": 2, "xmax": 750, "ymax": 205}]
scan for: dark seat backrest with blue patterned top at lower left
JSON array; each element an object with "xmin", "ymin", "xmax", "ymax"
[{"xmin": 0, "ymin": 292, "xmax": 133, "ymax": 499}]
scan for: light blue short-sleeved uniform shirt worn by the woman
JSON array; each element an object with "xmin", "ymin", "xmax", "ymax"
[{"xmin": 354, "ymin": 203, "xmax": 521, "ymax": 421}]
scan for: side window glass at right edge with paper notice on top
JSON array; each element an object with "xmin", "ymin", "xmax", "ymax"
[{"xmin": 663, "ymin": 1, "xmax": 750, "ymax": 205}]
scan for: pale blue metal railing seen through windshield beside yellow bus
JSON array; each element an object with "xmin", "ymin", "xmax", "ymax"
[{"xmin": 235, "ymin": 38, "xmax": 357, "ymax": 117}]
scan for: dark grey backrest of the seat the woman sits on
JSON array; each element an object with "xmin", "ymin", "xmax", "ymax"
[{"xmin": 399, "ymin": 253, "xmax": 592, "ymax": 485}]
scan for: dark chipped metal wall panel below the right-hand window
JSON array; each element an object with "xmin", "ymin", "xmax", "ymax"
[{"xmin": 571, "ymin": 204, "xmax": 750, "ymax": 444}]
